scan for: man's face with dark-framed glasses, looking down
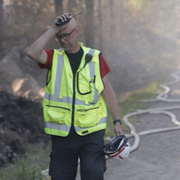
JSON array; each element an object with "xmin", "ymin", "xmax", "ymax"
[{"xmin": 56, "ymin": 28, "xmax": 78, "ymax": 52}]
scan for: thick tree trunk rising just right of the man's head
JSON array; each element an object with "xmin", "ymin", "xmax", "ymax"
[{"xmin": 85, "ymin": 0, "xmax": 94, "ymax": 48}]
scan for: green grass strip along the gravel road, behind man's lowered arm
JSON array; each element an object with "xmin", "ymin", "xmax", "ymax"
[{"xmin": 105, "ymin": 82, "xmax": 160, "ymax": 137}]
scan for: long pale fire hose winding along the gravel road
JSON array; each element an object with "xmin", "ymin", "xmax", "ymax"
[{"xmin": 123, "ymin": 72, "xmax": 180, "ymax": 152}]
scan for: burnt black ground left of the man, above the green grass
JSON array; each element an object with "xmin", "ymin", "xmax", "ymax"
[{"xmin": 0, "ymin": 91, "xmax": 49, "ymax": 168}]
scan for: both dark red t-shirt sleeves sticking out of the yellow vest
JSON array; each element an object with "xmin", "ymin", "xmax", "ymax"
[{"xmin": 38, "ymin": 49, "xmax": 111, "ymax": 78}]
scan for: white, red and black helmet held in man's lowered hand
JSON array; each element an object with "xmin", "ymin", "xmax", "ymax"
[{"xmin": 103, "ymin": 135, "xmax": 130, "ymax": 159}]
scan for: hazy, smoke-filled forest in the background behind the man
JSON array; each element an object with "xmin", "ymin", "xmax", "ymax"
[{"xmin": 0, "ymin": 0, "xmax": 180, "ymax": 98}]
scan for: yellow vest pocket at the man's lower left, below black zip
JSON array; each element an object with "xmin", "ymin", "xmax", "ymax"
[{"xmin": 47, "ymin": 106, "xmax": 70, "ymax": 124}]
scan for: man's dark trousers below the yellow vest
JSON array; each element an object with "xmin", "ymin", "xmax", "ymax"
[{"xmin": 49, "ymin": 128, "xmax": 106, "ymax": 180}]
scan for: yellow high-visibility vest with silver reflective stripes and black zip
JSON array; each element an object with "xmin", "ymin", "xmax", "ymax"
[{"xmin": 43, "ymin": 44, "xmax": 107, "ymax": 137}]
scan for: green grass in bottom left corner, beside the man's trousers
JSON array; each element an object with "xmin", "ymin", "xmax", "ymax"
[{"xmin": 0, "ymin": 145, "xmax": 50, "ymax": 180}]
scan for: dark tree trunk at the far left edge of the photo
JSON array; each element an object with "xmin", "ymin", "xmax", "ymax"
[{"xmin": 0, "ymin": 0, "xmax": 4, "ymax": 60}]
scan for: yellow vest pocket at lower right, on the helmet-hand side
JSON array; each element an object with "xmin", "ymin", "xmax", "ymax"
[{"xmin": 78, "ymin": 108, "xmax": 99, "ymax": 128}]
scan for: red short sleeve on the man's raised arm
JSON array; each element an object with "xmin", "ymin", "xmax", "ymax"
[{"xmin": 38, "ymin": 49, "xmax": 54, "ymax": 70}]
